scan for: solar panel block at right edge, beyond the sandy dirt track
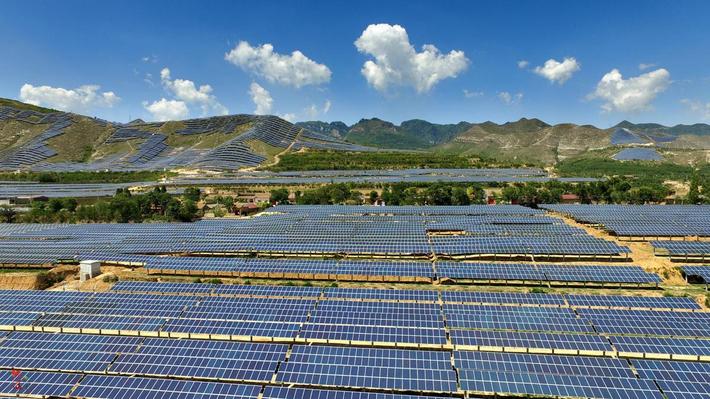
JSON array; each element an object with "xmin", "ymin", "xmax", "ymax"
[{"xmin": 541, "ymin": 204, "xmax": 710, "ymax": 238}]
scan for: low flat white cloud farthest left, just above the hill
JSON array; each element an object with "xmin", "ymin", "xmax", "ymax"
[{"xmin": 20, "ymin": 83, "xmax": 121, "ymax": 112}]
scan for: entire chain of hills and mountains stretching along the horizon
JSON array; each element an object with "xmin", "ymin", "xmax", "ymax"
[{"xmin": 0, "ymin": 99, "xmax": 710, "ymax": 171}]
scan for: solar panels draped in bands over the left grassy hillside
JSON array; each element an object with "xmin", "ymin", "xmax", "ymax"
[{"xmin": 0, "ymin": 106, "xmax": 373, "ymax": 171}]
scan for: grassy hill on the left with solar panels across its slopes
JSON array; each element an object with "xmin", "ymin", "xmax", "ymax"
[{"xmin": 0, "ymin": 99, "xmax": 373, "ymax": 171}]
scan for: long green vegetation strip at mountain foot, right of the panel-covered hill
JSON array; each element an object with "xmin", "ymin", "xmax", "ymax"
[{"xmin": 268, "ymin": 151, "xmax": 521, "ymax": 172}]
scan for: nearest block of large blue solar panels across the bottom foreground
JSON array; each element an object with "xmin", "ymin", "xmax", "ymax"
[{"xmin": 0, "ymin": 288, "xmax": 710, "ymax": 399}]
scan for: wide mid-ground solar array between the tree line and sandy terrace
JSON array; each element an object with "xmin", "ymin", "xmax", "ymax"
[{"xmin": 0, "ymin": 206, "xmax": 629, "ymax": 261}]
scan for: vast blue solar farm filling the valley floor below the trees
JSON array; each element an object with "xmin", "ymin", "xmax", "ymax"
[{"xmin": 0, "ymin": 205, "xmax": 710, "ymax": 399}]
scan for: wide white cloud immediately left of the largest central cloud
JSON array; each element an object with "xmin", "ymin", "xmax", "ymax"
[{"xmin": 224, "ymin": 41, "xmax": 331, "ymax": 88}]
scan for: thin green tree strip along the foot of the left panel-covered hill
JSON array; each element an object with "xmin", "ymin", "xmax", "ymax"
[{"xmin": 0, "ymin": 170, "xmax": 175, "ymax": 183}]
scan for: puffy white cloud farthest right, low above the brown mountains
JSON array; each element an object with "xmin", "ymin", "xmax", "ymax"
[{"xmin": 587, "ymin": 68, "xmax": 671, "ymax": 112}]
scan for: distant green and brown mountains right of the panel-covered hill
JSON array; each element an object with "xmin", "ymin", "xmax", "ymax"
[{"xmin": 296, "ymin": 118, "xmax": 710, "ymax": 164}]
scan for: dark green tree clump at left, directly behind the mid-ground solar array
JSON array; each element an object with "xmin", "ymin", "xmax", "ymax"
[{"xmin": 16, "ymin": 187, "xmax": 198, "ymax": 223}]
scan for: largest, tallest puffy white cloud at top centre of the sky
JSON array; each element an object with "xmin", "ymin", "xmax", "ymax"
[{"xmin": 355, "ymin": 24, "xmax": 469, "ymax": 93}]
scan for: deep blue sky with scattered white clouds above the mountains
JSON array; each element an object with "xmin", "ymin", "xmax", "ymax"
[{"xmin": 0, "ymin": 0, "xmax": 710, "ymax": 128}]
